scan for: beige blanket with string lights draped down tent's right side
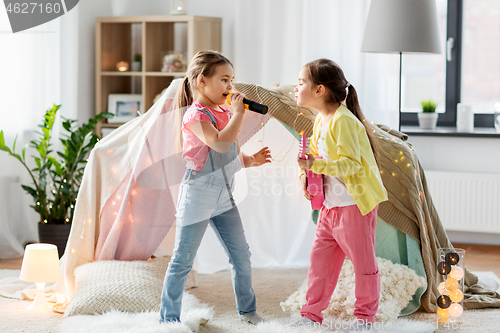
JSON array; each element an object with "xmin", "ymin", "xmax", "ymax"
[{"xmin": 375, "ymin": 126, "xmax": 500, "ymax": 312}]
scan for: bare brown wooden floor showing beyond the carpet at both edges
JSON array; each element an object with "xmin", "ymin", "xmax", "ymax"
[{"xmin": 0, "ymin": 243, "xmax": 500, "ymax": 277}]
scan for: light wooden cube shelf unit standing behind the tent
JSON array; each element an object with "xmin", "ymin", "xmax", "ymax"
[{"xmin": 95, "ymin": 15, "xmax": 222, "ymax": 136}]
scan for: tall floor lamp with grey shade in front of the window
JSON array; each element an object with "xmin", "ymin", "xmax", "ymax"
[{"xmin": 361, "ymin": 0, "xmax": 441, "ymax": 130}]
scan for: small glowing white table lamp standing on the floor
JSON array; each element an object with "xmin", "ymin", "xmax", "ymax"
[{"xmin": 19, "ymin": 243, "xmax": 62, "ymax": 312}]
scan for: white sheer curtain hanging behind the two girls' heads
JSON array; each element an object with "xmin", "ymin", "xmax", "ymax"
[{"xmin": 229, "ymin": 0, "xmax": 399, "ymax": 127}]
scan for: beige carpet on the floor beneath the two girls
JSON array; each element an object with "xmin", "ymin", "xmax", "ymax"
[{"xmin": 0, "ymin": 269, "xmax": 500, "ymax": 333}]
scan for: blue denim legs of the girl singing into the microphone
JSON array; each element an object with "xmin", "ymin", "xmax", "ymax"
[{"xmin": 160, "ymin": 207, "xmax": 256, "ymax": 323}]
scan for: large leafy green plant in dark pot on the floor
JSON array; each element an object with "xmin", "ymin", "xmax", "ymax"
[{"xmin": 0, "ymin": 104, "xmax": 113, "ymax": 256}]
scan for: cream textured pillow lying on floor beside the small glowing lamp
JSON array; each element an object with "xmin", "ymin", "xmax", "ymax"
[{"xmin": 64, "ymin": 256, "xmax": 170, "ymax": 316}]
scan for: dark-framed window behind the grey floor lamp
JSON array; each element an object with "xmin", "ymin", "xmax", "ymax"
[{"xmin": 401, "ymin": 0, "xmax": 500, "ymax": 127}]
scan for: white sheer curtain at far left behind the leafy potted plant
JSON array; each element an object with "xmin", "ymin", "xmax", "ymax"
[{"xmin": 0, "ymin": 7, "xmax": 77, "ymax": 259}]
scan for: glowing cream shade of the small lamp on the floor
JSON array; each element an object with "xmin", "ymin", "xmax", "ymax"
[{"xmin": 19, "ymin": 243, "xmax": 62, "ymax": 283}]
